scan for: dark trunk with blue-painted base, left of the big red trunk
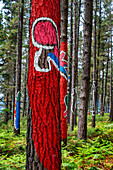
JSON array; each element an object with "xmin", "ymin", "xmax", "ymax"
[{"xmin": 14, "ymin": 0, "xmax": 24, "ymax": 134}]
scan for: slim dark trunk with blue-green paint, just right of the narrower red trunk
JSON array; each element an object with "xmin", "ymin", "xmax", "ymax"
[{"xmin": 67, "ymin": 0, "xmax": 73, "ymax": 123}]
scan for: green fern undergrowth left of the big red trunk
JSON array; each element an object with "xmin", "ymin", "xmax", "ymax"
[{"xmin": 0, "ymin": 118, "xmax": 27, "ymax": 170}]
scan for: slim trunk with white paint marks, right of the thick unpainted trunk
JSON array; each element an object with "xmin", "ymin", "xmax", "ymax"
[{"xmin": 92, "ymin": 0, "xmax": 97, "ymax": 127}]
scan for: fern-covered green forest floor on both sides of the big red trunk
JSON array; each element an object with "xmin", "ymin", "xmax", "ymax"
[{"xmin": 0, "ymin": 113, "xmax": 113, "ymax": 170}]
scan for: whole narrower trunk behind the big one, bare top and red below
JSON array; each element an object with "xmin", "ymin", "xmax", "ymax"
[{"xmin": 60, "ymin": 0, "xmax": 68, "ymax": 144}]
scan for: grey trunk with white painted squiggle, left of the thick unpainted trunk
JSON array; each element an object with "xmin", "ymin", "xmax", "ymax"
[{"xmin": 70, "ymin": 0, "xmax": 78, "ymax": 132}]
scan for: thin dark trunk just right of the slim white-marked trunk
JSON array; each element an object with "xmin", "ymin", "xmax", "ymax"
[{"xmin": 96, "ymin": 0, "xmax": 101, "ymax": 114}]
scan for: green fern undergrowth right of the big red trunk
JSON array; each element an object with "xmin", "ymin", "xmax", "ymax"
[{"xmin": 62, "ymin": 113, "xmax": 113, "ymax": 170}]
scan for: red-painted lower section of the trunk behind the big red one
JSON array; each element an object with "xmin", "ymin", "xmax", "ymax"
[{"xmin": 60, "ymin": 41, "xmax": 67, "ymax": 139}]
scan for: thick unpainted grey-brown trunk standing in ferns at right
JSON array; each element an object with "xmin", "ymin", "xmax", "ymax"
[{"xmin": 77, "ymin": 0, "xmax": 93, "ymax": 139}]
